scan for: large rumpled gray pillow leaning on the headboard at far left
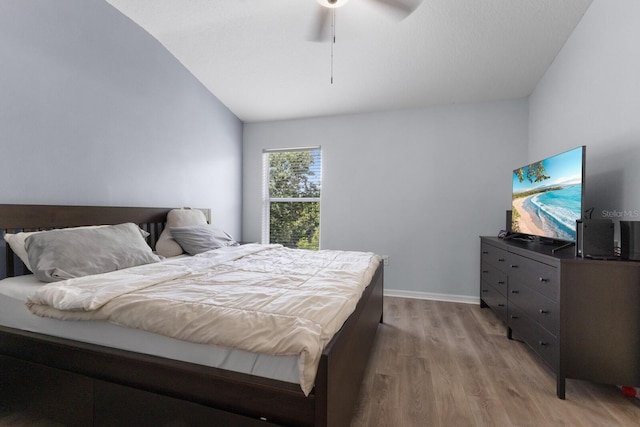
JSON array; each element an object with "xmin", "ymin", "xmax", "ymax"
[{"xmin": 25, "ymin": 223, "xmax": 160, "ymax": 282}]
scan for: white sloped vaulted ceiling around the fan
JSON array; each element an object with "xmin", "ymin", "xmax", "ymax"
[{"xmin": 107, "ymin": 0, "xmax": 591, "ymax": 122}]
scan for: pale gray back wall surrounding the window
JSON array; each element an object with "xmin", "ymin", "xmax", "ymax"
[{"xmin": 243, "ymin": 99, "xmax": 528, "ymax": 301}]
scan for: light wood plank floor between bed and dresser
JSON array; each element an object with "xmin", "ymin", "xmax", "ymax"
[{"xmin": 352, "ymin": 297, "xmax": 640, "ymax": 427}]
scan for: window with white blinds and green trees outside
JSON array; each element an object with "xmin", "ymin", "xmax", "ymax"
[{"xmin": 262, "ymin": 147, "xmax": 322, "ymax": 249}]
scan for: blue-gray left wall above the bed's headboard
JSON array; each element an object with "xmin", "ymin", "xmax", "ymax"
[{"xmin": 0, "ymin": 0, "xmax": 242, "ymax": 236}]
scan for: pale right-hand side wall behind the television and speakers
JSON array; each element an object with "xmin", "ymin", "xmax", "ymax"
[{"xmin": 529, "ymin": 0, "xmax": 640, "ymax": 231}]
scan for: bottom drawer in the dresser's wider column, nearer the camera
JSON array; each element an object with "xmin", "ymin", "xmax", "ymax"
[{"xmin": 507, "ymin": 304, "xmax": 560, "ymax": 372}]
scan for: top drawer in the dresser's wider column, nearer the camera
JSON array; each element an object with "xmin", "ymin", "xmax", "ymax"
[{"xmin": 507, "ymin": 253, "xmax": 560, "ymax": 301}]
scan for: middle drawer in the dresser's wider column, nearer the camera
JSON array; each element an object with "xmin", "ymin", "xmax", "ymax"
[{"xmin": 509, "ymin": 280, "xmax": 560, "ymax": 337}]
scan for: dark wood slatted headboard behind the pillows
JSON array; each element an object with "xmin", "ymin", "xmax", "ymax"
[{"xmin": 0, "ymin": 204, "xmax": 211, "ymax": 278}]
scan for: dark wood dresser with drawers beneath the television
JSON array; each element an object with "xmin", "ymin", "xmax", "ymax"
[{"xmin": 480, "ymin": 237, "xmax": 640, "ymax": 399}]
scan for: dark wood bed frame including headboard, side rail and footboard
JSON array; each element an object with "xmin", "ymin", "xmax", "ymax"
[{"xmin": 0, "ymin": 204, "xmax": 383, "ymax": 427}]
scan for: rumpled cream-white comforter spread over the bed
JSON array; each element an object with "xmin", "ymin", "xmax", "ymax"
[{"xmin": 27, "ymin": 244, "xmax": 380, "ymax": 395}]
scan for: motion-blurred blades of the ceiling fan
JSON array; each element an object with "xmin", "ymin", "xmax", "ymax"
[{"xmin": 309, "ymin": 0, "xmax": 422, "ymax": 41}]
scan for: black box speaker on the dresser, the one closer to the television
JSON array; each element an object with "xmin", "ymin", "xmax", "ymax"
[{"xmin": 576, "ymin": 219, "xmax": 615, "ymax": 258}]
